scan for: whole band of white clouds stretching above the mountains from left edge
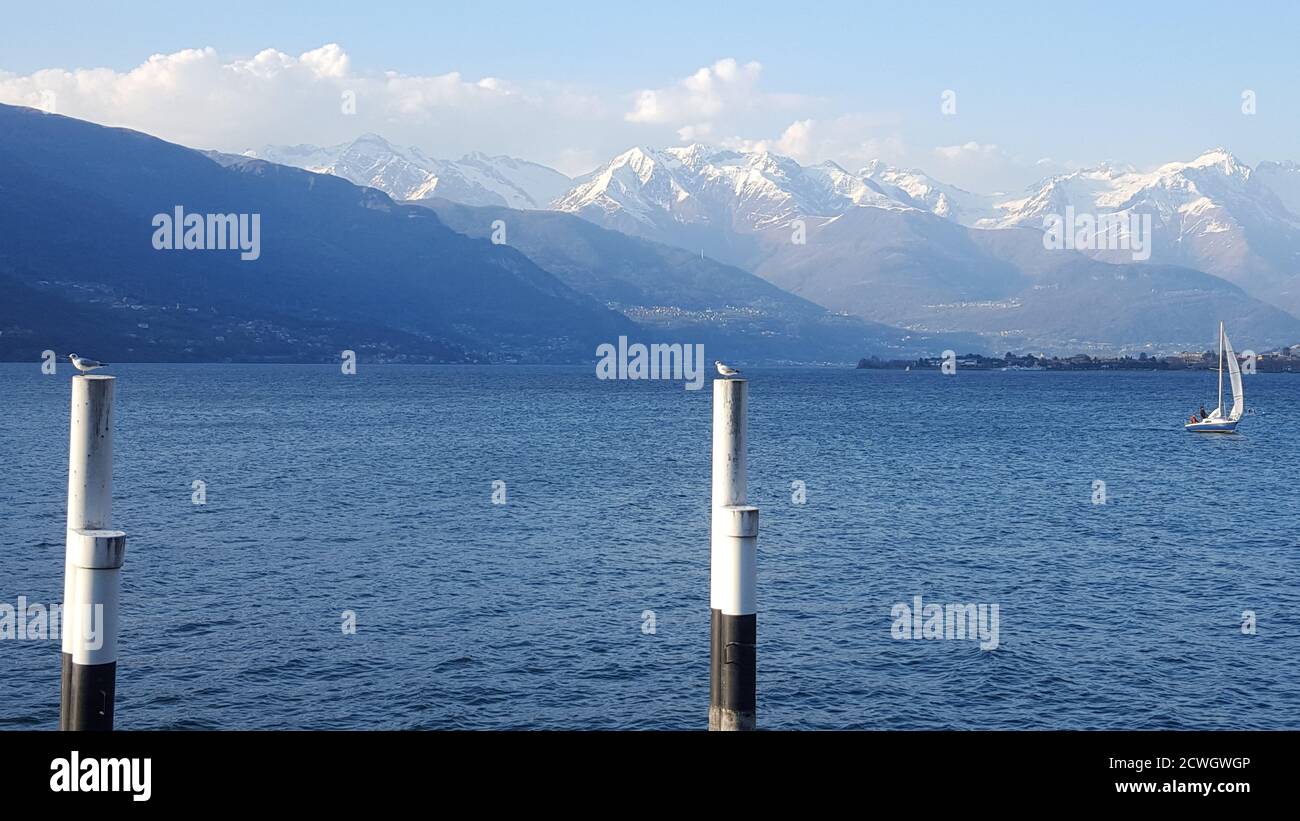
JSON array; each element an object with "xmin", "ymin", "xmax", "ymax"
[{"xmin": 0, "ymin": 43, "xmax": 1076, "ymax": 190}]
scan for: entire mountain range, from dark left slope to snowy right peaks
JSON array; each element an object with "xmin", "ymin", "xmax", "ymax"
[{"xmin": 0, "ymin": 107, "xmax": 1300, "ymax": 362}]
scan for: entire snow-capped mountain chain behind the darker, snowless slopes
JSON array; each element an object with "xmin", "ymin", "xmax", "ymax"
[{"xmin": 239, "ymin": 135, "xmax": 1300, "ymax": 327}]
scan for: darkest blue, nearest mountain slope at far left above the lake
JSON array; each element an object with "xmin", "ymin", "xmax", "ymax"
[{"xmin": 0, "ymin": 107, "xmax": 634, "ymax": 361}]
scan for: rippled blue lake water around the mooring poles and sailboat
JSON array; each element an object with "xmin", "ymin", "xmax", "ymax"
[{"xmin": 0, "ymin": 364, "xmax": 1300, "ymax": 729}]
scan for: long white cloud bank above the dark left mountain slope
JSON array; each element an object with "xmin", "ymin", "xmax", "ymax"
[{"xmin": 0, "ymin": 43, "xmax": 595, "ymax": 168}]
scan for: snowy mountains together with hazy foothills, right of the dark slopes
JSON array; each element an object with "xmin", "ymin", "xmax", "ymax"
[{"xmin": 253, "ymin": 138, "xmax": 1300, "ymax": 352}]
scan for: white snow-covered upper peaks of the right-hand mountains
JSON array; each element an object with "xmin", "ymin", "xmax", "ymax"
[{"xmin": 553, "ymin": 144, "xmax": 1300, "ymax": 246}]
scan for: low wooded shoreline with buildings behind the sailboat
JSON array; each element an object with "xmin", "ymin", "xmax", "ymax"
[{"xmin": 858, "ymin": 344, "xmax": 1300, "ymax": 373}]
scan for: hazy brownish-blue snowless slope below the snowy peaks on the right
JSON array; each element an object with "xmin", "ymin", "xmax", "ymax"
[{"xmin": 759, "ymin": 208, "xmax": 1300, "ymax": 353}]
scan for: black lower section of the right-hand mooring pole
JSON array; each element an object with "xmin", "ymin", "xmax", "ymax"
[{"xmin": 709, "ymin": 608, "xmax": 758, "ymax": 730}]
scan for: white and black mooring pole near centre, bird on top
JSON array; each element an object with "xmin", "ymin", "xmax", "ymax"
[{"xmin": 709, "ymin": 379, "xmax": 758, "ymax": 730}]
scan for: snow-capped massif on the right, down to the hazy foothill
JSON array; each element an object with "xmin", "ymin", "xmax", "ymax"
[{"xmin": 553, "ymin": 145, "xmax": 1300, "ymax": 312}]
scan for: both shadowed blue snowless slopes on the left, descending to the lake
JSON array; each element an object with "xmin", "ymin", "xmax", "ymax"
[{"xmin": 0, "ymin": 105, "xmax": 956, "ymax": 362}]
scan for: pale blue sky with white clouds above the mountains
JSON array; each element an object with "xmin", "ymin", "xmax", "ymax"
[{"xmin": 0, "ymin": 0, "xmax": 1300, "ymax": 190}]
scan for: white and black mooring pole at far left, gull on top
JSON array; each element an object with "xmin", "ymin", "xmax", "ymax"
[{"xmin": 59, "ymin": 375, "xmax": 126, "ymax": 730}]
